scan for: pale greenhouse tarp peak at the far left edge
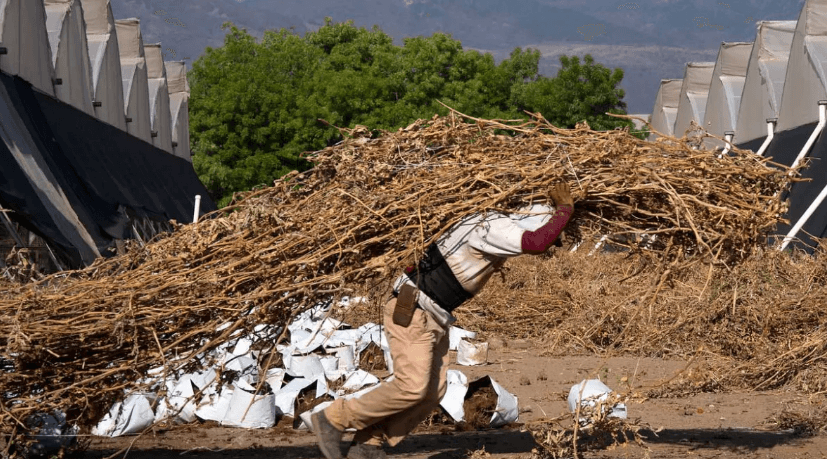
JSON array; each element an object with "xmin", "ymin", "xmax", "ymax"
[{"xmin": 0, "ymin": 0, "xmax": 55, "ymax": 96}]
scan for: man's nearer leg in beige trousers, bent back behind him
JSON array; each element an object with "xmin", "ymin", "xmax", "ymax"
[{"xmin": 324, "ymin": 298, "xmax": 447, "ymax": 430}]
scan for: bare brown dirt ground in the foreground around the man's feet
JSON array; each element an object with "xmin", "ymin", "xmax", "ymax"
[{"xmin": 85, "ymin": 340, "xmax": 827, "ymax": 459}]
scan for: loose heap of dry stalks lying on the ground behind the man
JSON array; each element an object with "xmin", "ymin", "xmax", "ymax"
[{"xmin": 457, "ymin": 248, "xmax": 827, "ymax": 396}]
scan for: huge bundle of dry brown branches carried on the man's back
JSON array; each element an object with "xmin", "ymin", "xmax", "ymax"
[{"xmin": 0, "ymin": 112, "xmax": 787, "ymax": 452}]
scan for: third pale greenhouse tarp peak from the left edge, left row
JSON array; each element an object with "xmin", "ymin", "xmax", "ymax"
[{"xmin": 81, "ymin": 0, "xmax": 126, "ymax": 131}]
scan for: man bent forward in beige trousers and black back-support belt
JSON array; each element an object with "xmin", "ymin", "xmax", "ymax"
[{"xmin": 312, "ymin": 182, "xmax": 574, "ymax": 459}]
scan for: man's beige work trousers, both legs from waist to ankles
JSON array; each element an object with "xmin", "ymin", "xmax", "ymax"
[{"xmin": 324, "ymin": 298, "xmax": 448, "ymax": 446}]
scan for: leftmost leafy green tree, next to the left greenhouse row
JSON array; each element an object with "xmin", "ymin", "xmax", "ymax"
[{"xmin": 188, "ymin": 27, "xmax": 326, "ymax": 205}]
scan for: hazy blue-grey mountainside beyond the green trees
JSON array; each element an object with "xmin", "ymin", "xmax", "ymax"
[{"xmin": 111, "ymin": 0, "xmax": 804, "ymax": 113}]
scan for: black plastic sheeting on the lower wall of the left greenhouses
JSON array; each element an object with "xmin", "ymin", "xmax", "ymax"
[{"xmin": 0, "ymin": 73, "xmax": 216, "ymax": 267}]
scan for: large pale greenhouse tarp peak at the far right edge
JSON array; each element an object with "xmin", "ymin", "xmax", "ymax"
[{"xmin": 776, "ymin": 0, "xmax": 827, "ymax": 132}]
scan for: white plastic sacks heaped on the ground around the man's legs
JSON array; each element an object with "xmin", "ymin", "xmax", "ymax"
[{"xmin": 92, "ymin": 298, "xmax": 518, "ymax": 437}]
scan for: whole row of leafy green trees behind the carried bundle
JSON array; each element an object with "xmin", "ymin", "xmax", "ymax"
[{"xmin": 188, "ymin": 18, "xmax": 631, "ymax": 205}]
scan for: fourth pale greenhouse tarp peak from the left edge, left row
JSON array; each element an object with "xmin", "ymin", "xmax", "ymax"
[{"xmin": 115, "ymin": 18, "xmax": 152, "ymax": 143}]
